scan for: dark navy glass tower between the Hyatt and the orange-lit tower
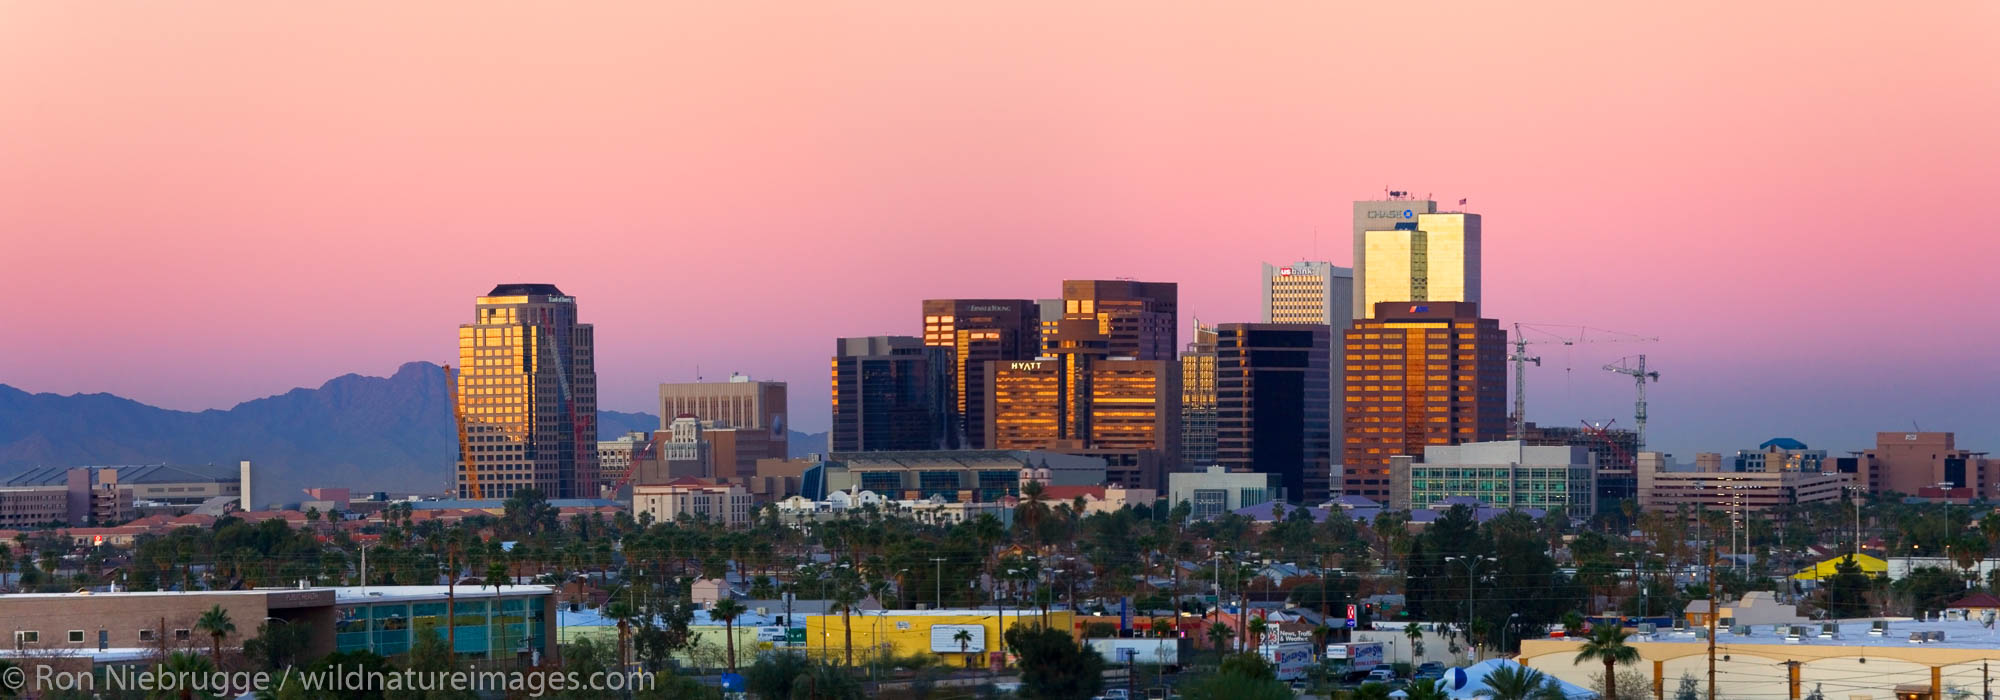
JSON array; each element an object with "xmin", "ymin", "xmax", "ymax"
[{"xmin": 1216, "ymin": 324, "xmax": 1334, "ymax": 504}]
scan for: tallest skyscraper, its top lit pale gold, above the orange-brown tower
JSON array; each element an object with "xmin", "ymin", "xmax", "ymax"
[{"xmin": 1354, "ymin": 202, "xmax": 1480, "ymax": 318}]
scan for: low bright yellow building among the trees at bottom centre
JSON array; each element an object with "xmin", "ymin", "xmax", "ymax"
[{"xmin": 806, "ymin": 608, "xmax": 1074, "ymax": 666}]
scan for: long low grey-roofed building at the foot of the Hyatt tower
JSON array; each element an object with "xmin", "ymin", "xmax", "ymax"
[{"xmin": 802, "ymin": 450, "xmax": 1106, "ymax": 502}]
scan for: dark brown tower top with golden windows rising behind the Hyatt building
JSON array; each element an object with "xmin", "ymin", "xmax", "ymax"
[{"xmin": 1042, "ymin": 280, "xmax": 1180, "ymax": 360}]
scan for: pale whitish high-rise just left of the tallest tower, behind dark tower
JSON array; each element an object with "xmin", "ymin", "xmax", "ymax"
[{"xmin": 1264, "ymin": 260, "xmax": 1354, "ymax": 468}]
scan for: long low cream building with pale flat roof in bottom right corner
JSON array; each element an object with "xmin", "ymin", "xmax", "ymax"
[{"xmin": 1518, "ymin": 606, "xmax": 2000, "ymax": 700}]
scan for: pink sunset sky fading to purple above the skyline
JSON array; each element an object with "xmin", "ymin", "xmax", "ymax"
[{"xmin": 0, "ymin": 0, "xmax": 2000, "ymax": 452}]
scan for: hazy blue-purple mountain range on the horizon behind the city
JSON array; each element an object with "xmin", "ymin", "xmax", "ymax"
[{"xmin": 0, "ymin": 362, "xmax": 826, "ymax": 504}]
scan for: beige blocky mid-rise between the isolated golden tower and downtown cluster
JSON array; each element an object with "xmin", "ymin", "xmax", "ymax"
[{"xmin": 660, "ymin": 374, "xmax": 790, "ymax": 478}]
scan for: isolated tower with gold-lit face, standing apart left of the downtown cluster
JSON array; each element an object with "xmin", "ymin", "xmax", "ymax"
[{"xmin": 456, "ymin": 284, "xmax": 598, "ymax": 498}]
